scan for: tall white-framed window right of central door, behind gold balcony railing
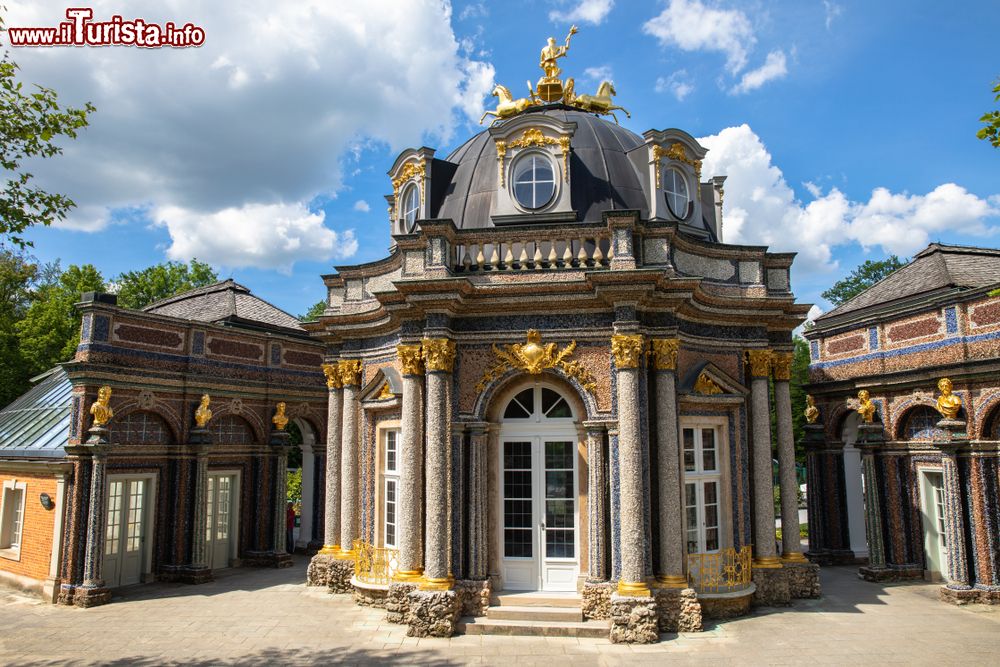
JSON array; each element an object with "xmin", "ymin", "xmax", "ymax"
[{"xmin": 679, "ymin": 417, "xmax": 731, "ymax": 553}]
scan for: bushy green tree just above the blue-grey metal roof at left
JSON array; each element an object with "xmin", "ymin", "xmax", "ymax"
[{"xmin": 15, "ymin": 264, "xmax": 105, "ymax": 375}]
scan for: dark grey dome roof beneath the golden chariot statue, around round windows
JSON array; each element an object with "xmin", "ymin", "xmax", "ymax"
[{"xmin": 434, "ymin": 105, "xmax": 648, "ymax": 229}]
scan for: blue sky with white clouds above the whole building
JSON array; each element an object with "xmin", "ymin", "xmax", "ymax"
[{"xmin": 0, "ymin": 0, "xmax": 1000, "ymax": 315}]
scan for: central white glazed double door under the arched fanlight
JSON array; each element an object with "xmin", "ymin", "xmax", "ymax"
[{"xmin": 500, "ymin": 430, "xmax": 580, "ymax": 591}]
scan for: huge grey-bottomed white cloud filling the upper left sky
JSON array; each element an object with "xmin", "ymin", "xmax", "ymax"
[{"xmin": 5, "ymin": 0, "xmax": 493, "ymax": 267}]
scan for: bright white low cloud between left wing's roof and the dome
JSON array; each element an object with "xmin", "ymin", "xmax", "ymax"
[{"xmin": 152, "ymin": 204, "xmax": 358, "ymax": 272}]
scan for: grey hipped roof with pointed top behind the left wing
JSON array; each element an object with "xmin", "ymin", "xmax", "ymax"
[{"xmin": 142, "ymin": 279, "xmax": 305, "ymax": 333}]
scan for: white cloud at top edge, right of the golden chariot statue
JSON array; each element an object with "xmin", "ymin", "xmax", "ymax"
[{"xmin": 642, "ymin": 0, "xmax": 757, "ymax": 74}]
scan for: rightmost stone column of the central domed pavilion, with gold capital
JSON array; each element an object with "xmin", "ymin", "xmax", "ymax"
[{"xmin": 773, "ymin": 352, "xmax": 806, "ymax": 563}]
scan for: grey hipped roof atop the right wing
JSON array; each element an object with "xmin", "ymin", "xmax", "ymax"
[{"xmin": 816, "ymin": 243, "xmax": 1000, "ymax": 323}]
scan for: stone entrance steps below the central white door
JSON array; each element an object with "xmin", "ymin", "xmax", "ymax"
[{"xmin": 458, "ymin": 592, "xmax": 611, "ymax": 639}]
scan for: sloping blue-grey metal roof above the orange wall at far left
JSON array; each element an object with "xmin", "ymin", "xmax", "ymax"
[{"xmin": 0, "ymin": 367, "xmax": 73, "ymax": 457}]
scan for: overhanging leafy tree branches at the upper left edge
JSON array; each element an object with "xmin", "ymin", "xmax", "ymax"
[{"xmin": 0, "ymin": 17, "xmax": 95, "ymax": 248}]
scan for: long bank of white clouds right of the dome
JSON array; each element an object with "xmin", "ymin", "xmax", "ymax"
[{"xmin": 699, "ymin": 125, "xmax": 1000, "ymax": 273}]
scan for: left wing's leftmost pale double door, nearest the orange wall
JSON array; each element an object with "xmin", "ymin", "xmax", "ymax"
[{"xmin": 104, "ymin": 476, "xmax": 152, "ymax": 588}]
